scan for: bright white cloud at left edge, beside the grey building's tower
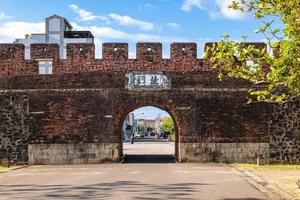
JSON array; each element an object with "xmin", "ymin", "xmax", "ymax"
[{"xmin": 0, "ymin": 21, "xmax": 45, "ymax": 43}]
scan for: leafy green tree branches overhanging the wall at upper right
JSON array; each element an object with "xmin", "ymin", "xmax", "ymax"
[{"xmin": 206, "ymin": 0, "xmax": 300, "ymax": 102}]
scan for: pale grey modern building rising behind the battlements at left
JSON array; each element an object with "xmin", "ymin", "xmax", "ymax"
[{"xmin": 14, "ymin": 15, "xmax": 94, "ymax": 59}]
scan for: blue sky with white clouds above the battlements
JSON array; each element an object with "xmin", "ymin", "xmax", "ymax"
[{"xmin": 0, "ymin": 0, "xmax": 272, "ymax": 57}]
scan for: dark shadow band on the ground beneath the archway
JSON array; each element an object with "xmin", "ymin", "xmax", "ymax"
[{"xmin": 121, "ymin": 155, "xmax": 177, "ymax": 163}]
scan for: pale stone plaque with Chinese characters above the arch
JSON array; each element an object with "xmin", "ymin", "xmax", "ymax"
[{"xmin": 126, "ymin": 72, "xmax": 171, "ymax": 90}]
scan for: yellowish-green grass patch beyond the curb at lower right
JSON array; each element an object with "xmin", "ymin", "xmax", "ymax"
[{"xmin": 238, "ymin": 164, "xmax": 300, "ymax": 199}]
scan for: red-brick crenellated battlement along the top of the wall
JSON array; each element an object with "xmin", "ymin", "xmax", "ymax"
[{"xmin": 0, "ymin": 43, "xmax": 266, "ymax": 77}]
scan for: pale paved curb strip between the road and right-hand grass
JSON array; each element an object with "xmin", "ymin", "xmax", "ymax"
[{"xmin": 231, "ymin": 164, "xmax": 293, "ymax": 200}]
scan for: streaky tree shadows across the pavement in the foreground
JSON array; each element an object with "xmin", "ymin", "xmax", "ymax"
[{"xmin": 0, "ymin": 181, "xmax": 207, "ymax": 200}]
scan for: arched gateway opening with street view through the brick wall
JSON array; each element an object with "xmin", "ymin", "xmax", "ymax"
[{"xmin": 120, "ymin": 106, "xmax": 178, "ymax": 163}]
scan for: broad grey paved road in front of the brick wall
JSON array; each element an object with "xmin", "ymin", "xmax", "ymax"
[{"xmin": 0, "ymin": 163, "xmax": 268, "ymax": 200}]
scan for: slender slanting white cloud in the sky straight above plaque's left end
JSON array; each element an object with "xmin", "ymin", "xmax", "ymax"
[{"xmin": 108, "ymin": 13, "xmax": 154, "ymax": 31}]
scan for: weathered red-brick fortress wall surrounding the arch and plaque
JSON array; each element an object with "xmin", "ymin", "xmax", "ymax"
[{"xmin": 0, "ymin": 43, "xmax": 300, "ymax": 164}]
